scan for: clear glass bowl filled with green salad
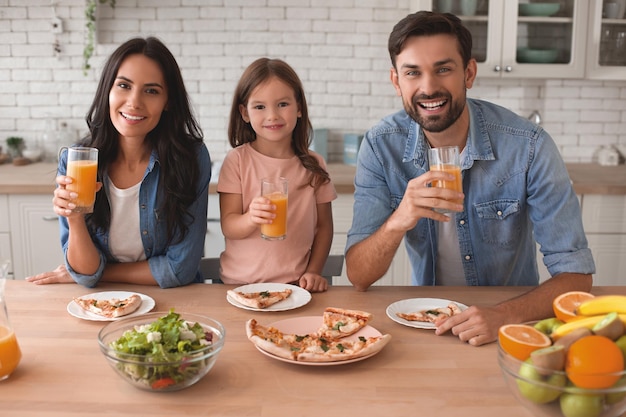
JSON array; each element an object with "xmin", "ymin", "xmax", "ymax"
[{"xmin": 98, "ymin": 311, "xmax": 225, "ymax": 392}]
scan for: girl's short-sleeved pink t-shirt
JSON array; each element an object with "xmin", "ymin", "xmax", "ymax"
[{"xmin": 217, "ymin": 143, "xmax": 337, "ymax": 284}]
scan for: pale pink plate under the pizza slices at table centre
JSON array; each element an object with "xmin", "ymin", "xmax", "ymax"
[{"xmin": 254, "ymin": 316, "xmax": 385, "ymax": 366}]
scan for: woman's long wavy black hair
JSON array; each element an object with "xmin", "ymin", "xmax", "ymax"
[{"xmin": 82, "ymin": 37, "xmax": 203, "ymax": 243}]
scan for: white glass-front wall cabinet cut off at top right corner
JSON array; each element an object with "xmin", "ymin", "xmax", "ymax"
[{"xmin": 587, "ymin": 0, "xmax": 626, "ymax": 80}]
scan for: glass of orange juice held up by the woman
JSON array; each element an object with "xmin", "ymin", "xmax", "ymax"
[{"xmin": 65, "ymin": 147, "xmax": 98, "ymax": 213}]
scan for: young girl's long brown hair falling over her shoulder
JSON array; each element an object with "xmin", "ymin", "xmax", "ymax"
[{"xmin": 228, "ymin": 58, "xmax": 330, "ymax": 188}]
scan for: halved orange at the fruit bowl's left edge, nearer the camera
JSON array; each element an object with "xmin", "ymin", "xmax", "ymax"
[{"xmin": 498, "ymin": 324, "xmax": 552, "ymax": 361}]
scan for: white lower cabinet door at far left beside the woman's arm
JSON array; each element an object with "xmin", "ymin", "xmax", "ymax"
[{"xmin": 6, "ymin": 194, "xmax": 63, "ymax": 279}]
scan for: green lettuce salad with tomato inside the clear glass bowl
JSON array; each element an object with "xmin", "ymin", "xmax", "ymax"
[{"xmin": 109, "ymin": 310, "xmax": 214, "ymax": 390}]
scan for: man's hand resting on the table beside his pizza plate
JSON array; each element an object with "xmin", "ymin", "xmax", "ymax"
[{"xmin": 435, "ymin": 306, "xmax": 507, "ymax": 346}]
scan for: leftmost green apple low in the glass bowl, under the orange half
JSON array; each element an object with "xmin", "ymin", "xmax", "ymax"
[{"xmin": 517, "ymin": 358, "xmax": 567, "ymax": 404}]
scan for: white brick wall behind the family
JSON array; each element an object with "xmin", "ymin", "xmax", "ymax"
[{"xmin": 0, "ymin": 0, "xmax": 626, "ymax": 166}]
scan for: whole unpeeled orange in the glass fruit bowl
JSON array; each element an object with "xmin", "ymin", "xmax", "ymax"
[{"xmin": 565, "ymin": 335, "xmax": 624, "ymax": 389}]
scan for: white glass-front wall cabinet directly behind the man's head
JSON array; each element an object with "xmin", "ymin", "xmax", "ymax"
[{"xmin": 412, "ymin": 0, "xmax": 584, "ymax": 78}]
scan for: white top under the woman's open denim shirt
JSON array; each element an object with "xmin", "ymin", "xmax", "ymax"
[{"xmin": 109, "ymin": 180, "xmax": 146, "ymax": 262}]
